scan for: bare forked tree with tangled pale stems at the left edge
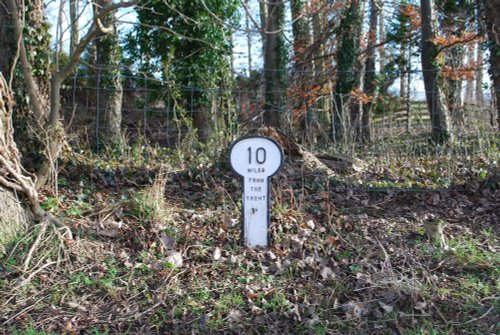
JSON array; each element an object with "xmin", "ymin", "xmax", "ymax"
[{"xmin": 0, "ymin": 0, "xmax": 137, "ymax": 244}]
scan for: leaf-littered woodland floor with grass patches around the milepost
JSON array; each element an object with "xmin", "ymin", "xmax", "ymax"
[{"xmin": 0, "ymin": 135, "xmax": 500, "ymax": 335}]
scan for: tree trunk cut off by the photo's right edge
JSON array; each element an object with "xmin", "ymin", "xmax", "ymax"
[{"xmin": 483, "ymin": 1, "xmax": 500, "ymax": 130}]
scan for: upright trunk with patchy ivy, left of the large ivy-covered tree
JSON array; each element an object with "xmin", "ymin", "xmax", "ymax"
[{"xmin": 95, "ymin": 0, "xmax": 123, "ymax": 146}]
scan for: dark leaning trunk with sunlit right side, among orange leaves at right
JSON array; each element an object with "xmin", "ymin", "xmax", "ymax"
[{"xmin": 420, "ymin": 0, "xmax": 453, "ymax": 143}]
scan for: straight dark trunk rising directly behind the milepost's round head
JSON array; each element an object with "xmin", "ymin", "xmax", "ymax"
[{"xmin": 264, "ymin": 0, "xmax": 286, "ymax": 128}]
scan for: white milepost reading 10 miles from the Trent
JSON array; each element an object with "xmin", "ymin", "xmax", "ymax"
[{"xmin": 229, "ymin": 136, "xmax": 283, "ymax": 247}]
